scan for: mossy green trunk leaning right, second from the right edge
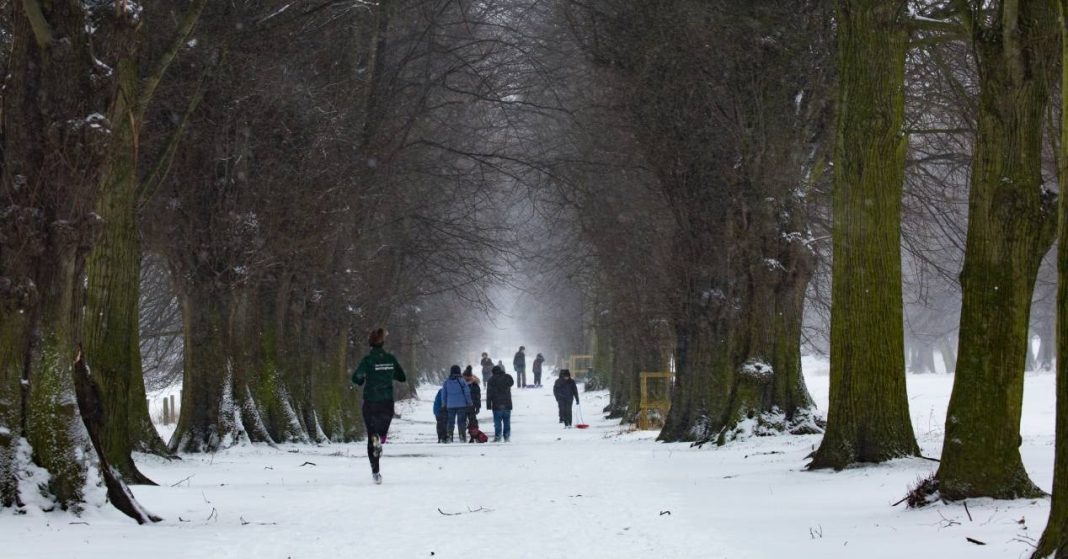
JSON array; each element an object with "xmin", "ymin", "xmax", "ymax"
[{"xmin": 936, "ymin": 1, "xmax": 1056, "ymax": 499}]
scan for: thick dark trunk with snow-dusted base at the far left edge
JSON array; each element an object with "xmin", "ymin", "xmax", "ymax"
[{"xmin": 0, "ymin": 0, "xmax": 131, "ymax": 510}]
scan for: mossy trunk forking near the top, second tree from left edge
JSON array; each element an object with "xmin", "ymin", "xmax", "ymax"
[{"xmin": 84, "ymin": 0, "xmax": 206, "ymax": 468}]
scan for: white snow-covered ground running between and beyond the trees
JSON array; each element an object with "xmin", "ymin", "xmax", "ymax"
[{"xmin": 0, "ymin": 359, "xmax": 1054, "ymax": 559}]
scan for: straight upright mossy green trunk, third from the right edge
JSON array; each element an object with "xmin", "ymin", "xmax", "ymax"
[{"xmin": 810, "ymin": 0, "xmax": 920, "ymax": 469}]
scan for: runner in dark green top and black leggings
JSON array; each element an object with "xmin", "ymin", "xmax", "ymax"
[{"xmin": 352, "ymin": 328, "xmax": 407, "ymax": 483}]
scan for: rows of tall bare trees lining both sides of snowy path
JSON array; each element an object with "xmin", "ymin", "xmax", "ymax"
[{"xmin": 0, "ymin": 0, "xmax": 1068, "ymax": 557}]
